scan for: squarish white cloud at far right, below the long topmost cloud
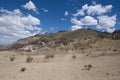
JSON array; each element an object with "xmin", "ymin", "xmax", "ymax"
[{"xmin": 97, "ymin": 15, "xmax": 116, "ymax": 29}]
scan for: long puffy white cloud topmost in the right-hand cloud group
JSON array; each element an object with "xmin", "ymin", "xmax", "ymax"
[{"xmin": 74, "ymin": 3, "xmax": 112, "ymax": 16}]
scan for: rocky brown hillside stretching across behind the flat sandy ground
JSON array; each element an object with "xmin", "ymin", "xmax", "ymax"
[{"xmin": 0, "ymin": 29, "xmax": 120, "ymax": 50}]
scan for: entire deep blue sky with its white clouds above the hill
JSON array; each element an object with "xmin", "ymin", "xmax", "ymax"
[{"xmin": 0, "ymin": 0, "xmax": 120, "ymax": 44}]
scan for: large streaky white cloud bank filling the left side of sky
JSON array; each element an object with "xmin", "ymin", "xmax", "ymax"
[{"xmin": 0, "ymin": 9, "xmax": 42, "ymax": 43}]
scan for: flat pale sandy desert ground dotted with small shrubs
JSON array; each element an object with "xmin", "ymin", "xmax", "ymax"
[{"xmin": 0, "ymin": 49, "xmax": 120, "ymax": 80}]
